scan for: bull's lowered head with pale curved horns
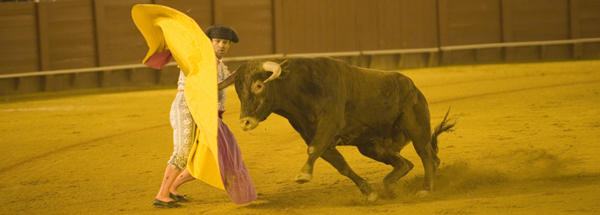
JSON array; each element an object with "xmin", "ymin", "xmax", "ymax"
[{"xmin": 235, "ymin": 58, "xmax": 287, "ymax": 130}]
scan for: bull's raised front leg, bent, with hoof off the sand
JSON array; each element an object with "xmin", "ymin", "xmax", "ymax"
[{"xmin": 294, "ymin": 118, "xmax": 343, "ymax": 184}]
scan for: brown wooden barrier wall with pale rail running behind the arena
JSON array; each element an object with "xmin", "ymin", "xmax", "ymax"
[{"xmin": 0, "ymin": 0, "xmax": 600, "ymax": 94}]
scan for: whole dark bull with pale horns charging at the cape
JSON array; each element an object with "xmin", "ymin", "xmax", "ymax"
[{"xmin": 219, "ymin": 57, "xmax": 454, "ymax": 201}]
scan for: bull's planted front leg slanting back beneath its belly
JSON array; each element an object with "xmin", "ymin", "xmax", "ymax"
[{"xmin": 321, "ymin": 146, "xmax": 377, "ymax": 202}]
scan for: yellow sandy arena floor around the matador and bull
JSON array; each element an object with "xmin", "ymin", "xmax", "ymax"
[{"xmin": 0, "ymin": 61, "xmax": 600, "ymax": 215}]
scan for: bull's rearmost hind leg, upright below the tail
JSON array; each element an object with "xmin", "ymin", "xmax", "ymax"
[{"xmin": 400, "ymin": 99, "xmax": 439, "ymax": 197}]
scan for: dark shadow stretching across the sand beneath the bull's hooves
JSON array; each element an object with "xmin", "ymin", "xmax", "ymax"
[{"xmin": 244, "ymin": 161, "xmax": 600, "ymax": 210}]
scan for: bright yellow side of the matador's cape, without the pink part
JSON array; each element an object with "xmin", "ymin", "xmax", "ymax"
[{"xmin": 131, "ymin": 4, "xmax": 224, "ymax": 189}]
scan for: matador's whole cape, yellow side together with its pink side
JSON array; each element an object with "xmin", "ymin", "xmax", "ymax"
[{"xmin": 131, "ymin": 4, "xmax": 256, "ymax": 204}]
